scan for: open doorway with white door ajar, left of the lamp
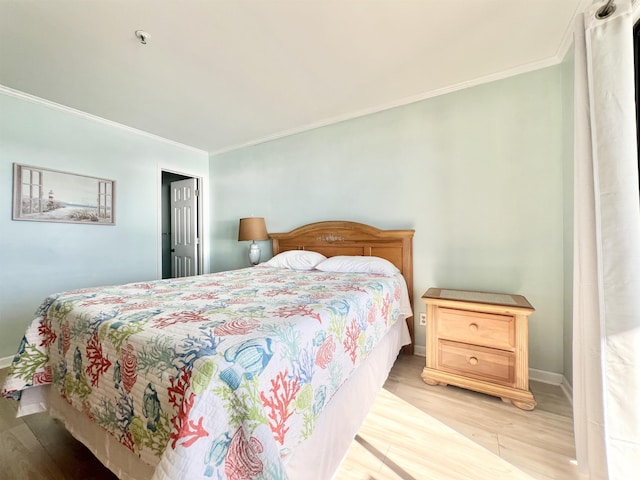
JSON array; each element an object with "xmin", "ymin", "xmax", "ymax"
[{"xmin": 160, "ymin": 170, "xmax": 203, "ymax": 278}]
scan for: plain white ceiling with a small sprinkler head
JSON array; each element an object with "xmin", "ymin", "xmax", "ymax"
[{"xmin": 0, "ymin": 0, "xmax": 591, "ymax": 152}]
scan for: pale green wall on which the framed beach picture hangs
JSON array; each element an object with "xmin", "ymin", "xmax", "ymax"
[{"xmin": 0, "ymin": 92, "xmax": 209, "ymax": 358}]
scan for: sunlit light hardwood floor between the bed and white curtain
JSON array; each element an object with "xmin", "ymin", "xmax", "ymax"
[{"xmin": 337, "ymin": 356, "xmax": 580, "ymax": 480}]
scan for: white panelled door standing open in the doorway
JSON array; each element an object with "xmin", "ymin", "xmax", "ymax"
[{"xmin": 170, "ymin": 178, "xmax": 199, "ymax": 278}]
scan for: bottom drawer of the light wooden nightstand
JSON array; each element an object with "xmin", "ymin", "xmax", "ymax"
[{"xmin": 437, "ymin": 340, "xmax": 515, "ymax": 385}]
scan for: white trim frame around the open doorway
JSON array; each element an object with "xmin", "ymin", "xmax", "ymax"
[{"xmin": 156, "ymin": 167, "xmax": 209, "ymax": 279}]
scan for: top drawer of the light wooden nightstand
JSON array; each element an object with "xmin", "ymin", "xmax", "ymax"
[{"xmin": 436, "ymin": 307, "xmax": 515, "ymax": 350}]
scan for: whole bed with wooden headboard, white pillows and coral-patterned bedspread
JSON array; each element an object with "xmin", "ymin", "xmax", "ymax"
[{"xmin": 3, "ymin": 222, "xmax": 413, "ymax": 480}]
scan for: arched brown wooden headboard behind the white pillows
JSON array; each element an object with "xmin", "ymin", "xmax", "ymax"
[{"xmin": 269, "ymin": 221, "xmax": 414, "ymax": 354}]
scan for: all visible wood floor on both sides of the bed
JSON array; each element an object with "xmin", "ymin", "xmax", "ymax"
[{"xmin": 0, "ymin": 355, "xmax": 579, "ymax": 480}]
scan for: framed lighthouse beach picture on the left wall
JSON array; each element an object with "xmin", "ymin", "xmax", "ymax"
[{"xmin": 13, "ymin": 163, "xmax": 115, "ymax": 225}]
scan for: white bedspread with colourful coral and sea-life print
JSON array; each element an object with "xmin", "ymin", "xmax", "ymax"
[{"xmin": 2, "ymin": 266, "xmax": 411, "ymax": 480}]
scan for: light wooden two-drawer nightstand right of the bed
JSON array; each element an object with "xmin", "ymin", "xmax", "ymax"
[{"xmin": 422, "ymin": 288, "xmax": 536, "ymax": 410}]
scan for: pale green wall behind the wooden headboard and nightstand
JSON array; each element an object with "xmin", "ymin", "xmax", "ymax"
[{"xmin": 210, "ymin": 66, "xmax": 565, "ymax": 373}]
